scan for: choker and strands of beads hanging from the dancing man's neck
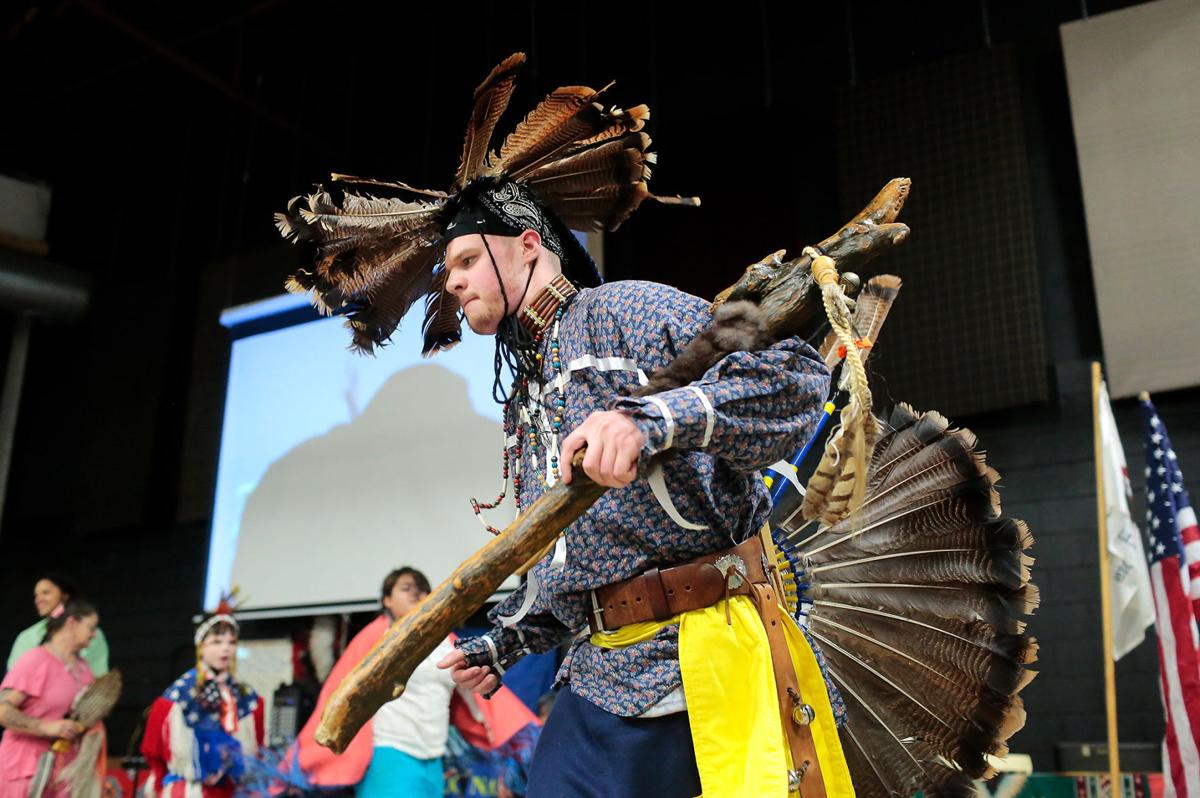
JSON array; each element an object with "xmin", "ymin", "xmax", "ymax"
[{"xmin": 470, "ymin": 275, "xmax": 578, "ymax": 535}]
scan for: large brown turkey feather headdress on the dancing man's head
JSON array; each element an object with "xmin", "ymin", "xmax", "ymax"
[{"xmin": 275, "ymin": 53, "xmax": 698, "ymax": 355}]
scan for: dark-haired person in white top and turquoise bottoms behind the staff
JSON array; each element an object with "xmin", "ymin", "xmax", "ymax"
[{"xmin": 355, "ymin": 566, "xmax": 455, "ymax": 798}]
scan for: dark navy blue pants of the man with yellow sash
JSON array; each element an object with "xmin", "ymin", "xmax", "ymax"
[{"xmin": 526, "ymin": 688, "xmax": 700, "ymax": 798}]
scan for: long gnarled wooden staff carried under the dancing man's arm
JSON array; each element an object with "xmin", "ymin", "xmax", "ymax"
[{"xmin": 317, "ymin": 178, "xmax": 910, "ymax": 754}]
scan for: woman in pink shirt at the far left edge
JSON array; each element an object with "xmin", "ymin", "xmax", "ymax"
[{"xmin": 0, "ymin": 599, "xmax": 100, "ymax": 798}]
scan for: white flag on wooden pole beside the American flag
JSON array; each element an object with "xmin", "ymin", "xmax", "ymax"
[{"xmin": 1097, "ymin": 383, "xmax": 1154, "ymax": 660}]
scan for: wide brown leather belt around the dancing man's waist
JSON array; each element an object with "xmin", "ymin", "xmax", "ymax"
[{"xmin": 588, "ymin": 535, "xmax": 768, "ymax": 634}]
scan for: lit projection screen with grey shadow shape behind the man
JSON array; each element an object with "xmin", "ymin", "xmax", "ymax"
[{"xmin": 205, "ymin": 304, "xmax": 512, "ymax": 608}]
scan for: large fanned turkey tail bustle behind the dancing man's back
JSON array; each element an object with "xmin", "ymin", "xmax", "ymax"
[{"xmin": 772, "ymin": 404, "xmax": 1039, "ymax": 798}]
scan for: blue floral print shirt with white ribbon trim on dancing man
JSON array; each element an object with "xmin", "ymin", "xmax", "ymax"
[{"xmin": 458, "ymin": 281, "xmax": 829, "ymax": 716}]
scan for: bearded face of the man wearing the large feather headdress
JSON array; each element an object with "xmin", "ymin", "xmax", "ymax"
[{"xmin": 446, "ymin": 235, "xmax": 528, "ymax": 335}]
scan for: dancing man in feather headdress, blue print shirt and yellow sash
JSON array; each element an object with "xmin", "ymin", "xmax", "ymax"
[{"xmin": 277, "ymin": 55, "xmax": 853, "ymax": 798}]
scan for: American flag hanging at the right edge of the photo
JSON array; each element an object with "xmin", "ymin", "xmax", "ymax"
[{"xmin": 1141, "ymin": 398, "xmax": 1200, "ymax": 798}]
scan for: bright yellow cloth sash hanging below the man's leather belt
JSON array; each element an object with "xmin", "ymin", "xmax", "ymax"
[{"xmin": 590, "ymin": 595, "xmax": 854, "ymax": 798}]
